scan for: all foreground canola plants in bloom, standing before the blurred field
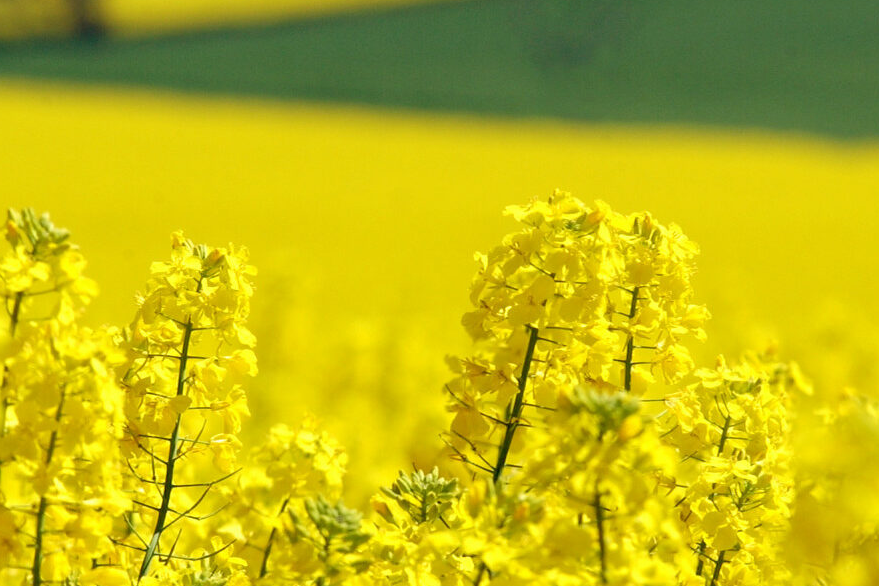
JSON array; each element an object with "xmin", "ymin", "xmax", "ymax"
[{"xmin": 0, "ymin": 191, "xmax": 879, "ymax": 586}]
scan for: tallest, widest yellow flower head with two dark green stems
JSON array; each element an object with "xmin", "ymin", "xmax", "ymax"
[{"xmin": 446, "ymin": 191, "xmax": 707, "ymax": 482}]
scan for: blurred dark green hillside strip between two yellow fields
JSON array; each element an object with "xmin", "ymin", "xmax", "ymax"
[{"xmin": 0, "ymin": 0, "xmax": 879, "ymax": 137}]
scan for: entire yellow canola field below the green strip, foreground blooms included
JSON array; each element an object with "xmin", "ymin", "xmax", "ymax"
[{"xmin": 0, "ymin": 74, "xmax": 879, "ymax": 586}]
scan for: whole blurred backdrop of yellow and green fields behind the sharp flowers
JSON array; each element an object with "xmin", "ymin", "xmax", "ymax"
[{"xmin": 0, "ymin": 0, "xmax": 879, "ymax": 499}]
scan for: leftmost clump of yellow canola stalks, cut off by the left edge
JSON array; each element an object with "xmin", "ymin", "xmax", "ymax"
[{"xmin": 0, "ymin": 209, "xmax": 128, "ymax": 586}]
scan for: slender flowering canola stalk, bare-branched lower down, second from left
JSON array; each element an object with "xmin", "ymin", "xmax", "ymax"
[{"xmin": 120, "ymin": 233, "xmax": 256, "ymax": 583}]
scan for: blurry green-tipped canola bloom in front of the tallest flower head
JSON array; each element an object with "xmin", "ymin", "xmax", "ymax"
[{"xmin": 516, "ymin": 387, "xmax": 692, "ymax": 586}]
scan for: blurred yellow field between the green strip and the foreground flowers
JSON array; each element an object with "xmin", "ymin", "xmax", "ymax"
[{"xmin": 0, "ymin": 81, "xmax": 879, "ymax": 495}]
